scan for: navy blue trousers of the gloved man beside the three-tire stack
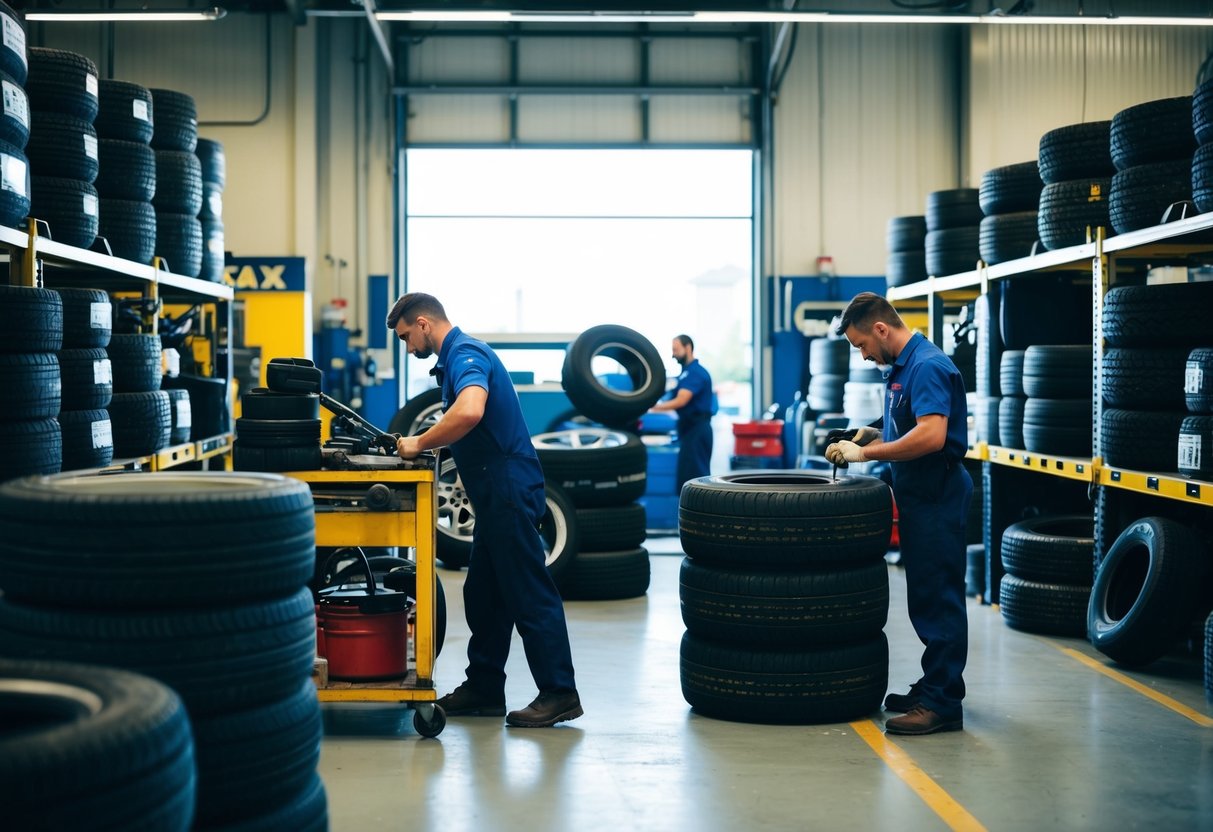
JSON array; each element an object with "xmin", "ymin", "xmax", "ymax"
[{"xmin": 893, "ymin": 462, "xmax": 973, "ymax": 718}]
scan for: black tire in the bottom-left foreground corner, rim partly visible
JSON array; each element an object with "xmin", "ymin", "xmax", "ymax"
[{"xmin": 0, "ymin": 659, "xmax": 194, "ymax": 830}]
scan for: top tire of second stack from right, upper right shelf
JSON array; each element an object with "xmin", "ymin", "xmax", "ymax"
[{"xmin": 1107, "ymin": 96, "xmax": 1196, "ymax": 171}]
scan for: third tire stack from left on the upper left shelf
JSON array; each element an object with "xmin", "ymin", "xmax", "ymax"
[{"xmin": 96, "ymin": 80, "xmax": 156, "ymax": 263}]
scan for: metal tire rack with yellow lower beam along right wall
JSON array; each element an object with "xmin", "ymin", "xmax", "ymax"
[{"xmin": 888, "ymin": 212, "xmax": 1213, "ymax": 604}]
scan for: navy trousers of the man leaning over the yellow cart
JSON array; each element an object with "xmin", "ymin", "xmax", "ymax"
[{"xmin": 460, "ymin": 460, "xmax": 576, "ymax": 699}]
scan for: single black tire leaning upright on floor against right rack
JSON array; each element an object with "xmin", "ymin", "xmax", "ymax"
[{"xmin": 1087, "ymin": 517, "xmax": 1208, "ymax": 666}]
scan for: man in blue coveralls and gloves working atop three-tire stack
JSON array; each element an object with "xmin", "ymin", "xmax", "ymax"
[{"xmin": 826, "ymin": 292, "xmax": 973, "ymax": 735}]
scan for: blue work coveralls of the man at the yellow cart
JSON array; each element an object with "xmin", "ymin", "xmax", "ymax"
[{"xmin": 432, "ymin": 326, "xmax": 576, "ymax": 699}]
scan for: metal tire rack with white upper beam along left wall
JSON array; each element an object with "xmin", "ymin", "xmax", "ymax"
[{"xmin": 0, "ymin": 218, "xmax": 234, "ymax": 472}]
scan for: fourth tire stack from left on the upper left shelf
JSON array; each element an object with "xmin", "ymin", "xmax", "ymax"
[{"xmin": 152, "ymin": 89, "xmax": 203, "ymax": 278}]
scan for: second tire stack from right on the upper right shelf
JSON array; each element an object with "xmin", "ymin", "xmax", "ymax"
[{"xmin": 1107, "ymin": 96, "xmax": 1196, "ymax": 234}]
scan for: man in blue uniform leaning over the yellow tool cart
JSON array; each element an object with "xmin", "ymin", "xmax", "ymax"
[{"xmin": 387, "ymin": 292, "xmax": 582, "ymax": 728}]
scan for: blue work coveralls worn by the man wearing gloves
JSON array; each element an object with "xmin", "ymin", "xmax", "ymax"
[{"xmin": 884, "ymin": 332, "xmax": 973, "ymax": 719}]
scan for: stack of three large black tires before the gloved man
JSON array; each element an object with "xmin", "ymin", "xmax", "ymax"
[{"xmin": 678, "ymin": 471, "xmax": 893, "ymax": 723}]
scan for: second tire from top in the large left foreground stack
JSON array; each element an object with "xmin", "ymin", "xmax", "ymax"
[{"xmin": 0, "ymin": 587, "xmax": 315, "ymax": 718}]
